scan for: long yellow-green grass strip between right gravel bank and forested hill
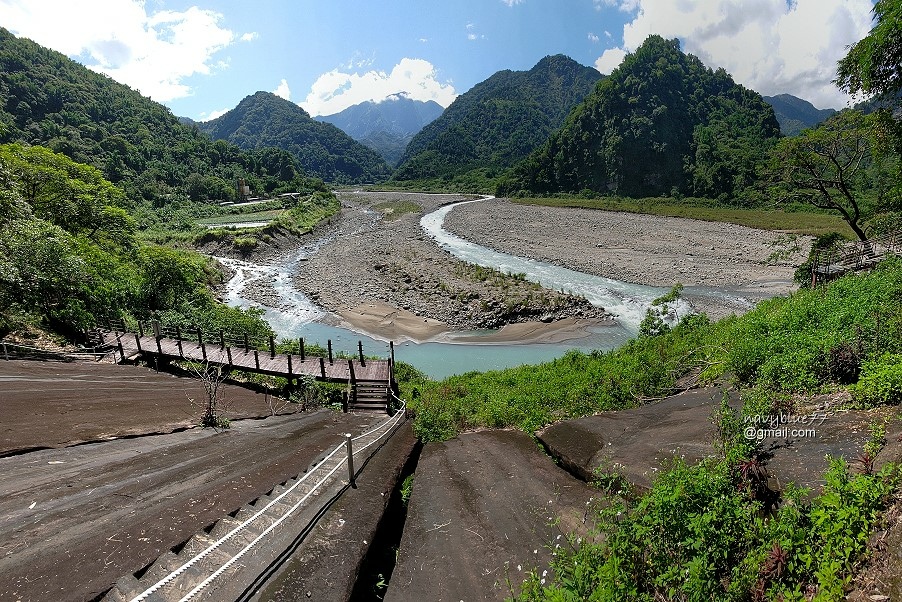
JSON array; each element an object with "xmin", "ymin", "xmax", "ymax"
[{"xmin": 510, "ymin": 197, "xmax": 855, "ymax": 238}]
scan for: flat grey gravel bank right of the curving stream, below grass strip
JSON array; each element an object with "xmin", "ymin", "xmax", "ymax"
[{"xmin": 444, "ymin": 199, "xmax": 811, "ymax": 319}]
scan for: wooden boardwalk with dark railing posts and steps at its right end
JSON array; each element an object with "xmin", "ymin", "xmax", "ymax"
[{"xmin": 99, "ymin": 330, "xmax": 394, "ymax": 408}]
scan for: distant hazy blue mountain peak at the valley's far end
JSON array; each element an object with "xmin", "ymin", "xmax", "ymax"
[{"xmin": 316, "ymin": 94, "xmax": 444, "ymax": 165}]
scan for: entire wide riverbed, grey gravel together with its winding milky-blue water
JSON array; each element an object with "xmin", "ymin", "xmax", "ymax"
[{"xmin": 222, "ymin": 192, "xmax": 804, "ymax": 378}]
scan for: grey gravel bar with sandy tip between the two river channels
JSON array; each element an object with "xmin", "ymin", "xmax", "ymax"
[{"xmin": 294, "ymin": 193, "xmax": 613, "ymax": 342}]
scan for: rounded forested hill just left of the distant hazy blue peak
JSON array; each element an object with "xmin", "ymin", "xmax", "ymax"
[{"xmin": 199, "ymin": 92, "xmax": 390, "ymax": 184}]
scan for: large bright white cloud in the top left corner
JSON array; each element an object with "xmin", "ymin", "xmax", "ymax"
[{"xmin": 0, "ymin": 0, "xmax": 235, "ymax": 102}]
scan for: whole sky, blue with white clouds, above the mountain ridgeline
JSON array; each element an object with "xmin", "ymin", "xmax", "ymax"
[{"xmin": 0, "ymin": 0, "xmax": 873, "ymax": 119}]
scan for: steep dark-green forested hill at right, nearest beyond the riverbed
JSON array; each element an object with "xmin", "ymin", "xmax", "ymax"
[{"xmin": 512, "ymin": 36, "xmax": 780, "ymax": 198}]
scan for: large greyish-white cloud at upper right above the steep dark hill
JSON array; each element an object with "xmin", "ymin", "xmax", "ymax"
[{"xmin": 595, "ymin": 0, "xmax": 873, "ymax": 108}]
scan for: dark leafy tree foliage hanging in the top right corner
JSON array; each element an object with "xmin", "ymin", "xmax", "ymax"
[{"xmin": 834, "ymin": 0, "xmax": 902, "ymax": 101}]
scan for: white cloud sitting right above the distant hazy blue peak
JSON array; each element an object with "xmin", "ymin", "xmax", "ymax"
[{"xmin": 301, "ymin": 58, "xmax": 457, "ymax": 115}]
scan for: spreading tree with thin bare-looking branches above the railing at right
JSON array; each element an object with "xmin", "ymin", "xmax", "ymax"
[{"xmin": 765, "ymin": 110, "xmax": 874, "ymax": 240}]
